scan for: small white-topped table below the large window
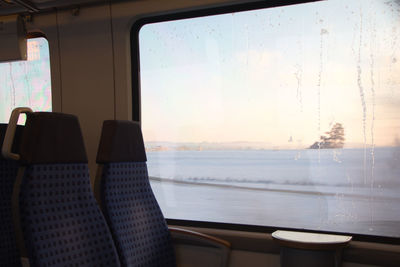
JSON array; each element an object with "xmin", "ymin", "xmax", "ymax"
[{"xmin": 272, "ymin": 230, "xmax": 352, "ymax": 267}]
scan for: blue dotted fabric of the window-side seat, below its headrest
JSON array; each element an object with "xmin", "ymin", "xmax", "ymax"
[{"xmin": 100, "ymin": 162, "xmax": 176, "ymax": 267}]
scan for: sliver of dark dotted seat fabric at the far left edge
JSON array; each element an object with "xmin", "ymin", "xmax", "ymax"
[{"xmin": 0, "ymin": 158, "xmax": 21, "ymax": 267}]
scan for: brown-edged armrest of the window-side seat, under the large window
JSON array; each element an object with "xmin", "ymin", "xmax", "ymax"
[{"xmin": 168, "ymin": 227, "xmax": 231, "ymax": 249}]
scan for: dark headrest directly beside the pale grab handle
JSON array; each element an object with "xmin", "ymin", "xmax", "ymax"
[{"xmin": 20, "ymin": 112, "xmax": 88, "ymax": 164}]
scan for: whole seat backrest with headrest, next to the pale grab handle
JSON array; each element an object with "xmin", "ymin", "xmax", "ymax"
[{"xmin": 14, "ymin": 112, "xmax": 120, "ymax": 266}]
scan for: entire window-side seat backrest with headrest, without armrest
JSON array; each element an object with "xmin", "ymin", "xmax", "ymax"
[{"xmin": 95, "ymin": 120, "xmax": 176, "ymax": 267}]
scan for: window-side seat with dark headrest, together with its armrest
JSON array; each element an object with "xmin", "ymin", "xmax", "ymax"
[{"xmin": 95, "ymin": 120, "xmax": 230, "ymax": 267}]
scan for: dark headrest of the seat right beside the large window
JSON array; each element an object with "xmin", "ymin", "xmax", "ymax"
[{"xmin": 96, "ymin": 120, "xmax": 147, "ymax": 163}]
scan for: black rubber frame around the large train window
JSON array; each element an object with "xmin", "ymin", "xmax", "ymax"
[{"xmin": 130, "ymin": 0, "xmax": 400, "ymax": 245}]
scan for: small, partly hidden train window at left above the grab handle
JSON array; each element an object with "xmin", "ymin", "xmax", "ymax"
[{"xmin": 0, "ymin": 37, "xmax": 51, "ymax": 123}]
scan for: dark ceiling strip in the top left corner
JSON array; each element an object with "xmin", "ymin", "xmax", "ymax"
[{"xmin": 0, "ymin": 0, "xmax": 114, "ymax": 16}]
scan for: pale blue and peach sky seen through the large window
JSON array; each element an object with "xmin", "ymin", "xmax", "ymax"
[{"xmin": 139, "ymin": 0, "xmax": 400, "ymax": 148}]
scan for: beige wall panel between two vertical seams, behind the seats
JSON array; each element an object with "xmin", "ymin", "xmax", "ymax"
[{"xmin": 58, "ymin": 6, "xmax": 114, "ymax": 178}]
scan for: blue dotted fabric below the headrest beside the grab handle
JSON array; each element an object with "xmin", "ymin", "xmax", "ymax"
[{"xmin": 19, "ymin": 163, "xmax": 120, "ymax": 267}]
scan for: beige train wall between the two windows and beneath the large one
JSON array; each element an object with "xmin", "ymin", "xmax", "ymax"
[{"xmin": 12, "ymin": 0, "xmax": 400, "ymax": 267}]
